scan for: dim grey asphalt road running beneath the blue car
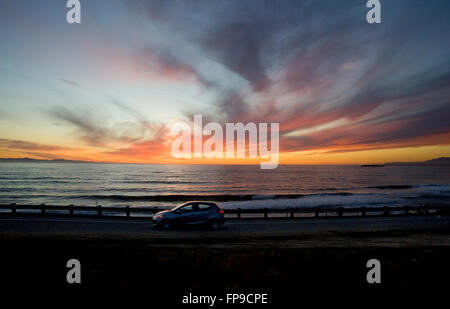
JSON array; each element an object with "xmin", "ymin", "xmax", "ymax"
[{"xmin": 0, "ymin": 215, "xmax": 450, "ymax": 239}]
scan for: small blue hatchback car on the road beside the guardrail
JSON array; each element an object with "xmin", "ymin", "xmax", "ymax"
[{"xmin": 153, "ymin": 202, "xmax": 225, "ymax": 230}]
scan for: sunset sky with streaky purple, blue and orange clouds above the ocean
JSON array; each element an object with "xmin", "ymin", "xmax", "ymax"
[{"xmin": 0, "ymin": 0, "xmax": 450, "ymax": 164}]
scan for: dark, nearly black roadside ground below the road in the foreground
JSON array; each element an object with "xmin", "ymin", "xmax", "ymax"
[{"xmin": 0, "ymin": 230, "xmax": 450, "ymax": 304}]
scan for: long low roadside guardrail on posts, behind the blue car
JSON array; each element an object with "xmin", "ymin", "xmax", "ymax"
[{"xmin": 0, "ymin": 204, "xmax": 450, "ymax": 219}]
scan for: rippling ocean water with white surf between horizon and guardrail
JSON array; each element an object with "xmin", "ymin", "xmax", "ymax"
[{"xmin": 0, "ymin": 162, "xmax": 450, "ymax": 209}]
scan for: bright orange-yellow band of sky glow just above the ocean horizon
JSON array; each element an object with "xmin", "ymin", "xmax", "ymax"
[{"xmin": 0, "ymin": 145, "xmax": 450, "ymax": 165}]
